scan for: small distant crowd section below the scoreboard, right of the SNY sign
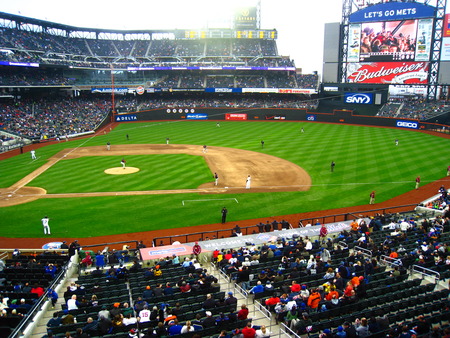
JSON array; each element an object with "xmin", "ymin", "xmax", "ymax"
[{"xmin": 377, "ymin": 97, "xmax": 450, "ymax": 121}]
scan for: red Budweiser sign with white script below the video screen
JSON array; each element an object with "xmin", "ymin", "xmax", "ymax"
[{"xmin": 347, "ymin": 62, "xmax": 428, "ymax": 84}]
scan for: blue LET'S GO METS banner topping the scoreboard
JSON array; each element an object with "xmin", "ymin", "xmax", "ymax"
[{"xmin": 350, "ymin": 2, "xmax": 435, "ymax": 22}]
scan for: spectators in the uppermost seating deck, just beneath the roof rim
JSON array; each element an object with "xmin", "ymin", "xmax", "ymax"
[{"xmin": 0, "ymin": 27, "xmax": 294, "ymax": 74}]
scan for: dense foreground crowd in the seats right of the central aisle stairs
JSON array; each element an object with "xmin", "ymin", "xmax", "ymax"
[{"xmin": 213, "ymin": 207, "xmax": 450, "ymax": 337}]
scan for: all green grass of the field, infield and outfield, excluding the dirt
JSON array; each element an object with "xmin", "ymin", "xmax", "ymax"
[{"xmin": 0, "ymin": 121, "xmax": 450, "ymax": 238}]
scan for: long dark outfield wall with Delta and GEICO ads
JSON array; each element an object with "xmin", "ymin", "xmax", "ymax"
[{"xmin": 114, "ymin": 107, "xmax": 450, "ymax": 131}]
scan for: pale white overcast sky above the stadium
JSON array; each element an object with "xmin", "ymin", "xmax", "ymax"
[{"xmin": 0, "ymin": 0, "xmax": 342, "ymax": 73}]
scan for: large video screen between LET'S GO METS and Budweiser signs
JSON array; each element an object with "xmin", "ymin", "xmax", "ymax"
[{"xmin": 347, "ymin": 18, "xmax": 433, "ymax": 62}]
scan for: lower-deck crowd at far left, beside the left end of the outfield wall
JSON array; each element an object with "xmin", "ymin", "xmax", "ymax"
[{"xmin": 0, "ymin": 98, "xmax": 111, "ymax": 139}]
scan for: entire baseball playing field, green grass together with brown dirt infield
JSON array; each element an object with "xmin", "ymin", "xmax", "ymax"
[{"xmin": 0, "ymin": 120, "xmax": 450, "ymax": 238}]
